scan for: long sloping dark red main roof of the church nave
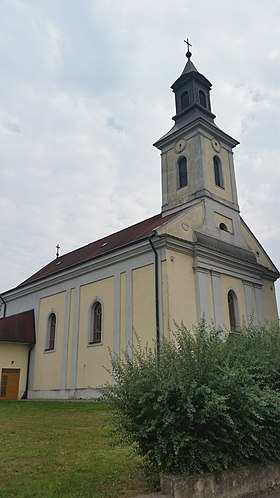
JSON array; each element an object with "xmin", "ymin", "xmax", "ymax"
[{"xmin": 18, "ymin": 213, "xmax": 176, "ymax": 287}]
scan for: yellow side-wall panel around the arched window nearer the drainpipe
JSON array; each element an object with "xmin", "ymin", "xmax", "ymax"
[{"xmin": 76, "ymin": 277, "xmax": 114, "ymax": 388}]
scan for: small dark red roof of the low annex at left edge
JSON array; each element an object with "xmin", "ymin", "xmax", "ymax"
[{"xmin": 0, "ymin": 310, "xmax": 36, "ymax": 344}]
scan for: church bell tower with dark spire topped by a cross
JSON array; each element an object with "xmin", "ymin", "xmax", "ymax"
[{"xmin": 154, "ymin": 40, "xmax": 245, "ymax": 247}]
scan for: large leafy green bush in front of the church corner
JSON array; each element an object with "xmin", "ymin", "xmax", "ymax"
[{"xmin": 105, "ymin": 322, "xmax": 280, "ymax": 474}]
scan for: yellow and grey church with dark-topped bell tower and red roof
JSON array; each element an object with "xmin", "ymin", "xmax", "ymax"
[{"xmin": 0, "ymin": 45, "xmax": 279, "ymax": 400}]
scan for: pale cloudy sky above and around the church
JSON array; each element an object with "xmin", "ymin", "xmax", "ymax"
[{"xmin": 0, "ymin": 0, "xmax": 280, "ymax": 310}]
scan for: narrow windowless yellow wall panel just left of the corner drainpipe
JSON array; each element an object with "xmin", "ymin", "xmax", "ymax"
[{"xmin": 132, "ymin": 265, "xmax": 156, "ymax": 345}]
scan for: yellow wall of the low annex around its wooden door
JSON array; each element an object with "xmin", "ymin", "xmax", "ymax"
[{"xmin": 0, "ymin": 342, "xmax": 29, "ymax": 399}]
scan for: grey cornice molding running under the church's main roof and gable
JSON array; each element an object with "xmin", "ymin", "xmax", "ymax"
[{"xmin": 5, "ymin": 231, "xmax": 279, "ymax": 302}]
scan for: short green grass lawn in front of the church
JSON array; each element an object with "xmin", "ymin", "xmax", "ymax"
[{"xmin": 0, "ymin": 401, "xmax": 151, "ymax": 498}]
